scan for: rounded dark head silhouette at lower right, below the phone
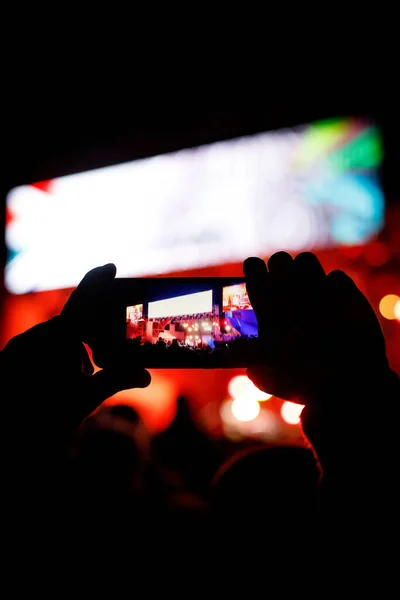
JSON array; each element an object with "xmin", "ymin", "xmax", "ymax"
[{"xmin": 211, "ymin": 446, "xmax": 319, "ymax": 541}]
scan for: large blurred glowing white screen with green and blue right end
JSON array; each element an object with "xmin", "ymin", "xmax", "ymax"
[{"xmin": 5, "ymin": 119, "xmax": 384, "ymax": 294}]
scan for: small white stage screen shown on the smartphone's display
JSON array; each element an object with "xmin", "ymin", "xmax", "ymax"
[{"xmin": 148, "ymin": 290, "xmax": 212, "ymax": 319}]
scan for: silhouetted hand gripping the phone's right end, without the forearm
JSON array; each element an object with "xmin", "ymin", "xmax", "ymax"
[{"xmin": 244, "ymin": 252, "xmax": 388, "ymax": 404}]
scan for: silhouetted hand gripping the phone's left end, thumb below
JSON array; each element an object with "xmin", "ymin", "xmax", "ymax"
[{"xmin": 0, "ymin": 265, "xmax": 150, "ymax": 458}]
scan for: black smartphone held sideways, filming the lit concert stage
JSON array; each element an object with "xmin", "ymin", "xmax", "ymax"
[{"xmin": 115, "ymin": 277, "xmax": 259, "ymax": 369}]
